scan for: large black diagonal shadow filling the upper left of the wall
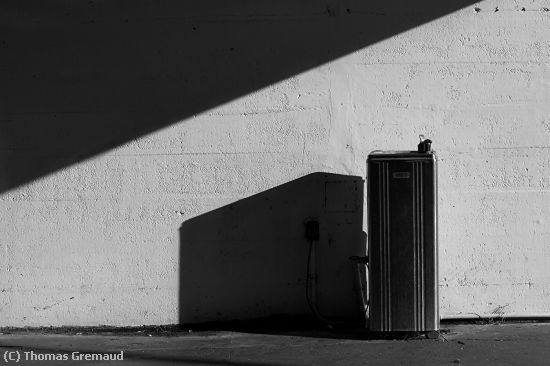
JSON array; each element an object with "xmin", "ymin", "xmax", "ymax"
[{"xmin": 0, "ymin": 0, "xmax": 474, "ymax": 192}]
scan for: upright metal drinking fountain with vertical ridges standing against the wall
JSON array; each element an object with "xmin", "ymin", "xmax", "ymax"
[{"xmin": 367, "ymin": 140, "xmax": 439, "ymax": 332}]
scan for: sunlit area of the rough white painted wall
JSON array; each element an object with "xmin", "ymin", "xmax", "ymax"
[{"xmin": 0, "ymin": 0, "xmax": 550, "ymax": 326}]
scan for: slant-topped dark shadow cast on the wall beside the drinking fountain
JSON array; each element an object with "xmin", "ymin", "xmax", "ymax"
[{"xmin": 179, "ymin": 173, "xmax": 366, "ymax": 324}]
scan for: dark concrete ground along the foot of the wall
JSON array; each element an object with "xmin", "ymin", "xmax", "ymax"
[{"xmin": 0, "ymin": 323, "xmax": 550, "ymax": 366}]
